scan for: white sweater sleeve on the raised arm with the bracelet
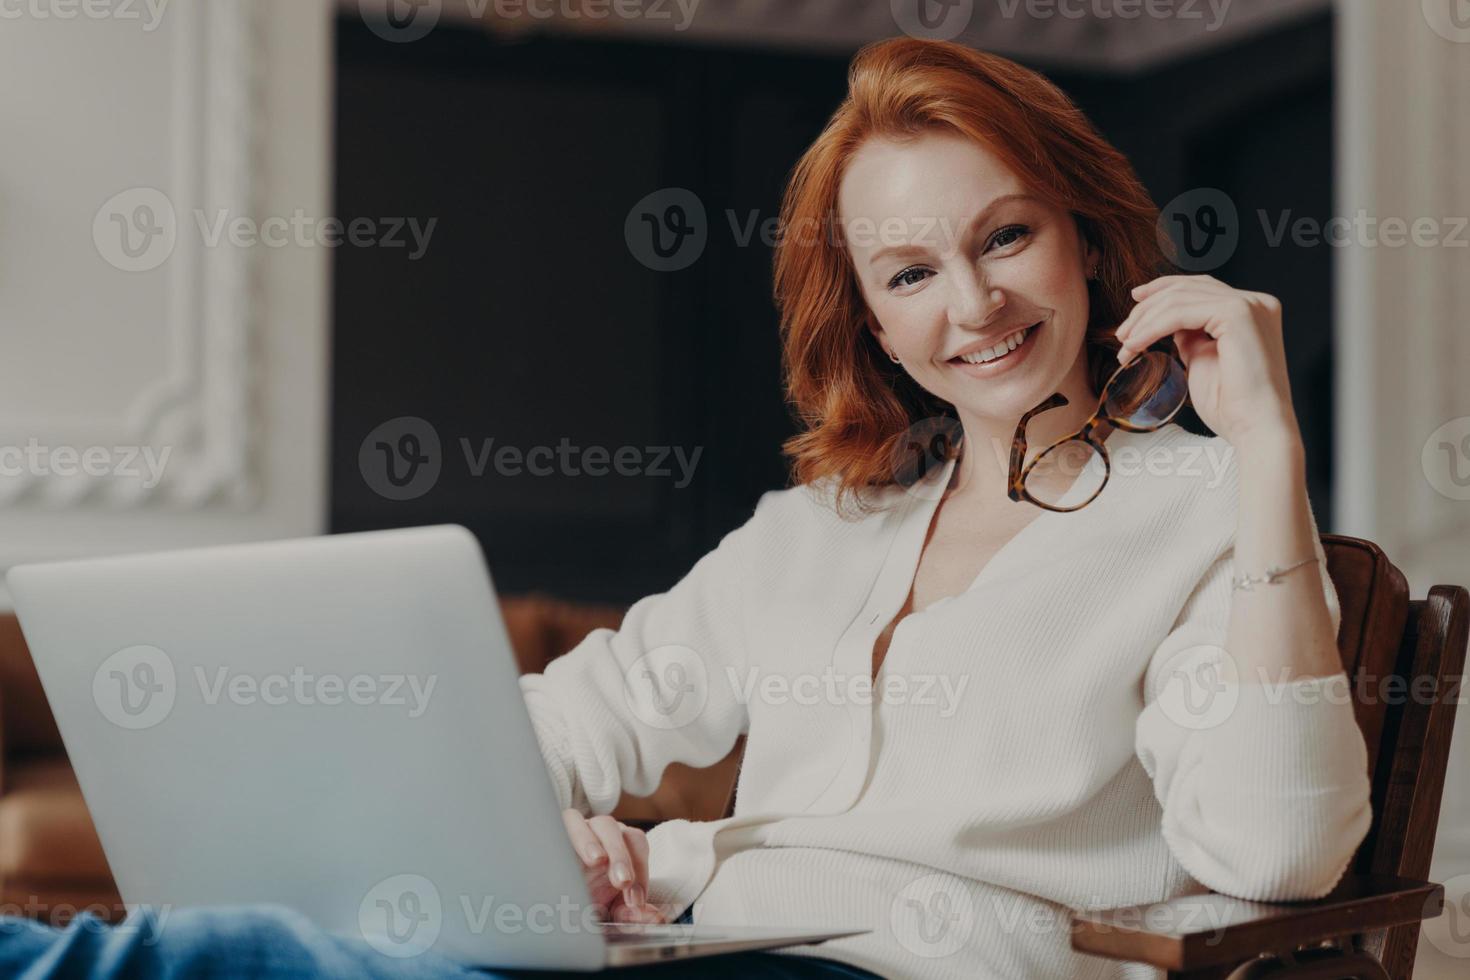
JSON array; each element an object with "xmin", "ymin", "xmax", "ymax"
[{"xmin": 1135, "ymin": 533, "xmax": 1372, "ymax": 901}]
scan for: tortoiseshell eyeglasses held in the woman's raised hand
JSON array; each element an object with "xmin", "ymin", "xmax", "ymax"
[{"xmin": 1005, "ymin": 350, "xmax": 1189, "ymax": 513}]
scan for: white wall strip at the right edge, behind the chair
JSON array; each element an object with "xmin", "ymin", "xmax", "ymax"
[{"xmin": 1333, "ymin": 0, "xmax": 1470, "ymax": 980}]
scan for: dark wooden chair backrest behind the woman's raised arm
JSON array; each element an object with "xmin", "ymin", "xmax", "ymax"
[{"xmin": 1322, "ymin": 535, "xmax": 1470, "ymax": 977}]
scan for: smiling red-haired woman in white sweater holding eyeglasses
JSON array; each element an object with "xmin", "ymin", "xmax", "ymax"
[{"xmin": 5, "ymin": 38, "xmax": 1370, "ymax": 979}]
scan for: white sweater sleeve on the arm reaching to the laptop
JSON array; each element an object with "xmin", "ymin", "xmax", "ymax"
[{"xmin": 520, "ymin": 495, "xmax": 769, "ymax": 814}]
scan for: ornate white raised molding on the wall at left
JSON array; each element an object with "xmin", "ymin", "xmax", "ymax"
[{"xmin": 0, "ymin": 0, "xmax": 265, "ymax": 508}]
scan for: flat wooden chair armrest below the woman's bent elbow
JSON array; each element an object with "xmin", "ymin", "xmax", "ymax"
[{"xmin": 1072, "ymin": 874, "xmax": 1445, "ymax": 971}]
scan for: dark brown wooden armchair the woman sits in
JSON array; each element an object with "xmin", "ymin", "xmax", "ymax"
[{"xmin": 1072, "ymin": 535, "xmax": 1470, "ymax": 980}]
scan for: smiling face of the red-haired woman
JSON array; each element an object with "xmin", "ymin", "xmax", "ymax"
[{"xmin": 838, "ymin": 131, "xmax": 1098, "ymax": 441}]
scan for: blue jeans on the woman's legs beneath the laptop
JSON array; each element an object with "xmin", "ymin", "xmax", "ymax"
[{"xmin": 0, "ymin": 905, "xmax": 876, "ymax": 980}]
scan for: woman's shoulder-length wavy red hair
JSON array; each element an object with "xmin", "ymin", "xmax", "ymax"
[{"xmin": 773, "ymin": 37, "xmax": 1173, "ymax": 513}]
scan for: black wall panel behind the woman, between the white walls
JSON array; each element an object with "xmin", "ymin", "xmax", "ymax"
[{"xmin": 331, "ymin": 16, "xmax": 1332, "ymax": 601}]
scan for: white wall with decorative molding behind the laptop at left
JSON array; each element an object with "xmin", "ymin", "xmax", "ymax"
[{"xmin": 0, "ymin": 0, "xmax": 332, "ymax": 601}]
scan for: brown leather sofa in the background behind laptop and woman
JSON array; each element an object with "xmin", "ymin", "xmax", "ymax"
[{"xmin": 0, "ymin": 594, "xmax": 742, "ymax": 923}]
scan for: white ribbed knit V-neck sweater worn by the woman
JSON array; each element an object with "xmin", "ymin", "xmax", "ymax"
[{"xmin": 522, "ymin": 423, "xmax": 1370, "ymax": 980}]
